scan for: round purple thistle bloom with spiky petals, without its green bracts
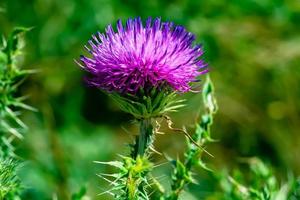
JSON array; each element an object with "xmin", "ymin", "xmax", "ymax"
[{"xmin": 79, "ymin": 18, "xmax": 208, "ymax": 94}]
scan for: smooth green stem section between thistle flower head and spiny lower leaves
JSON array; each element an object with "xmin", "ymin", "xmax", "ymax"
[{"xmin": 137, "ymin": 119, "xmax": 153, "ymax": 157}]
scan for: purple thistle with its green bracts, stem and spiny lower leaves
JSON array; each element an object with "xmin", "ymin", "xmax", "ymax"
[{"xmin": 77, "ymin": 18, "xmax": 208, "ymax": 200}]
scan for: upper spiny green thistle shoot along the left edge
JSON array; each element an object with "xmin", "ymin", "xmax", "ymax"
[{"xmin": 0, "ymin": 28, "xmax": 35, "ymax": 140}]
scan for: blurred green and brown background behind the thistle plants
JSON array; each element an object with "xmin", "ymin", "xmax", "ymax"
[{"xmin": 0, "ymin": 0, "xmax": 300, "ymax": 200}]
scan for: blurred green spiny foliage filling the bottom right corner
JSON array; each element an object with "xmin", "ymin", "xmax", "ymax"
[{"xmin": 218, "ymin": 158, "xmax": 299, "ymax": 200}]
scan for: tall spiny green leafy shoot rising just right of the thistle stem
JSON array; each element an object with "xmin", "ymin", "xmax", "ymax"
[{"xmin": 165, "ymin": 76, "xmax": 217, "ymax": 200}]
